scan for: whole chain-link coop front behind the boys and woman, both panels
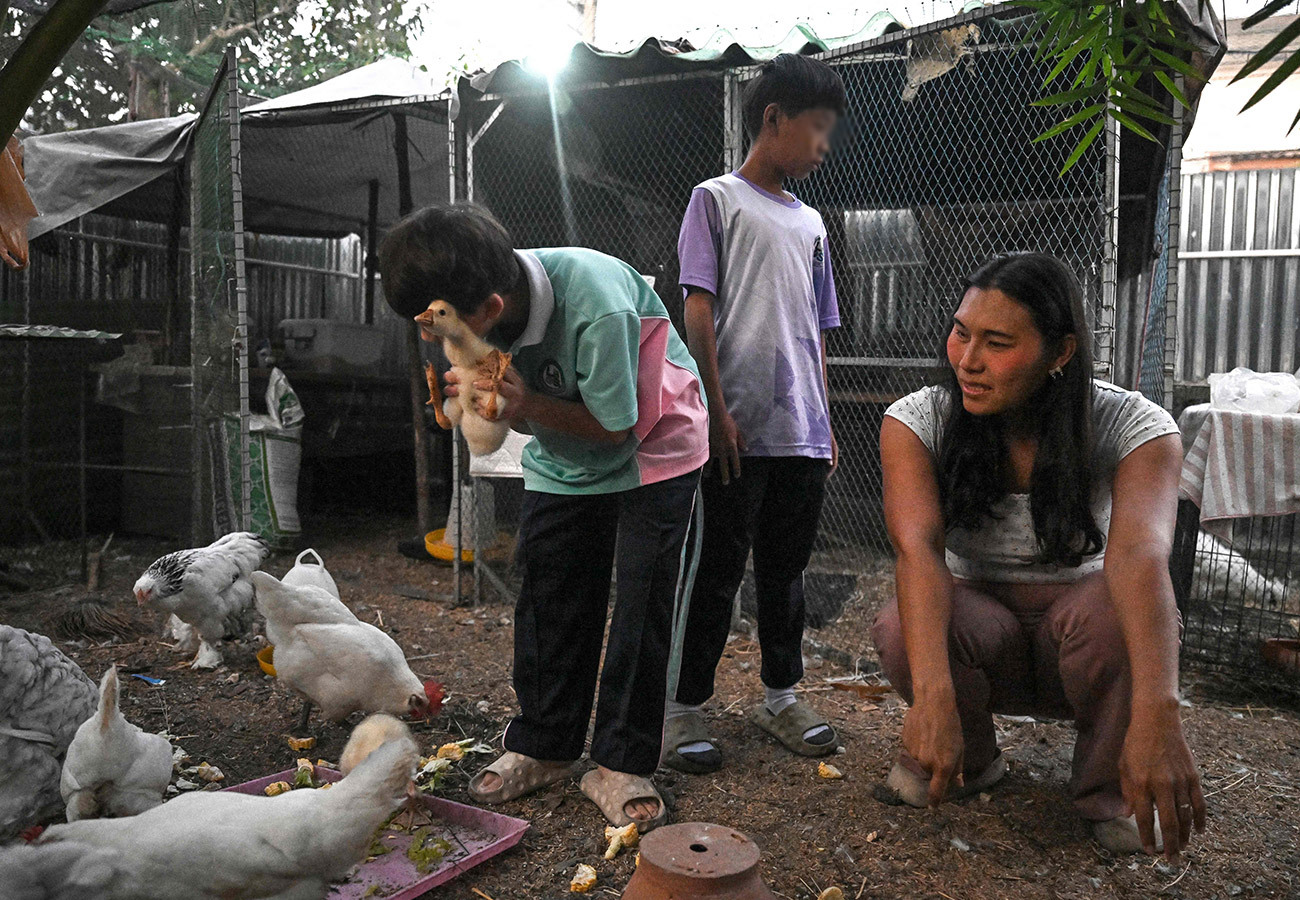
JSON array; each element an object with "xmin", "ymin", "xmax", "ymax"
[{"xmin": 455, "ymin": 5, "xmax": 1115, "ymax": 619}]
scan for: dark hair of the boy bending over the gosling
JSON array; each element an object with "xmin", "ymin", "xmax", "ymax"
[{"xmin": 380, "ymin": 203, "xmax": 523, "ymax": 319}]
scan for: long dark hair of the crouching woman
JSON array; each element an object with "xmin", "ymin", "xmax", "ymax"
[{"xmin": 939, "ymin": 254, "xmax": 1105, "ymax": 567}]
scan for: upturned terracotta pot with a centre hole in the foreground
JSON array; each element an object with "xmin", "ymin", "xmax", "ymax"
[{"xmin": 623, "ymin": 822, "xmax": 776, "ymax": 900}]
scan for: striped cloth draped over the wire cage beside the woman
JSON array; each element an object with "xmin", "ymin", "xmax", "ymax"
[{"xmin": 1178, "ymin": 406, "xmax": 1300, "ymax": 541}]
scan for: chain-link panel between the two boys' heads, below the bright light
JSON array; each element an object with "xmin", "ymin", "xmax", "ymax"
[{"xmin": 456, "ymin": 72, "xmax": 725, "ymax": 325}]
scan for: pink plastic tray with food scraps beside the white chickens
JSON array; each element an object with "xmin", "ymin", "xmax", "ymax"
[{"xmin": 225, "ymin": 766, "xmax": 528, "ymax": 900}]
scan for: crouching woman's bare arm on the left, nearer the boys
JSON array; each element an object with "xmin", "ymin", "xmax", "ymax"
[{"xmin": 880, "ymin": 417, "xmax": 965, "ymax": 805}]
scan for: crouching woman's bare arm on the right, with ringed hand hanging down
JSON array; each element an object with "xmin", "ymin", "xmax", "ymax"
[{"xmin": 1105, "ymin": 434, "xmax": 1205, "ymax": 858}]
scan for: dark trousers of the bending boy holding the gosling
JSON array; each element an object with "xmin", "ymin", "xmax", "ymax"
[{"xmin": 504, "ymin": 470, "xmax": 699, "ymax": 775}]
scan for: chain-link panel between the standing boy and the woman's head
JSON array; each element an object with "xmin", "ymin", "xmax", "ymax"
[{"xmin": 794, "ymin": 17, "xmax": 1110, "ymax": 571}]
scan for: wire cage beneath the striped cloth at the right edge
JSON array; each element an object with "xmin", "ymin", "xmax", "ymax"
[{"xmin": 1173, "ymin": 501, "xmax": 1300, "ymax": 691}]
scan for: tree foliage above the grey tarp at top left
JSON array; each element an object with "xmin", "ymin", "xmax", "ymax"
[{"xmin": 0, "ymin": 0, "xmax": 420, "ymax": 131}]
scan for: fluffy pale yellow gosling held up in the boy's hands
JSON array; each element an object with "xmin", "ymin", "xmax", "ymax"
[{"xmin": 415, "ymin": 300, "xmax": 511, "ymax": 457}]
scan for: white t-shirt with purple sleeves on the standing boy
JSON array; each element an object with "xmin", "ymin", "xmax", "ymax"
[{"xmin": 677, "ymin": 172, "xmax": 840, "ymax": 459}]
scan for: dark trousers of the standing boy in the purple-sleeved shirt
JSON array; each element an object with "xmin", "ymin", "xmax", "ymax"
[{"xmin": 676, "ymin": 457, "xmax": 831, "ymax": 705}]
